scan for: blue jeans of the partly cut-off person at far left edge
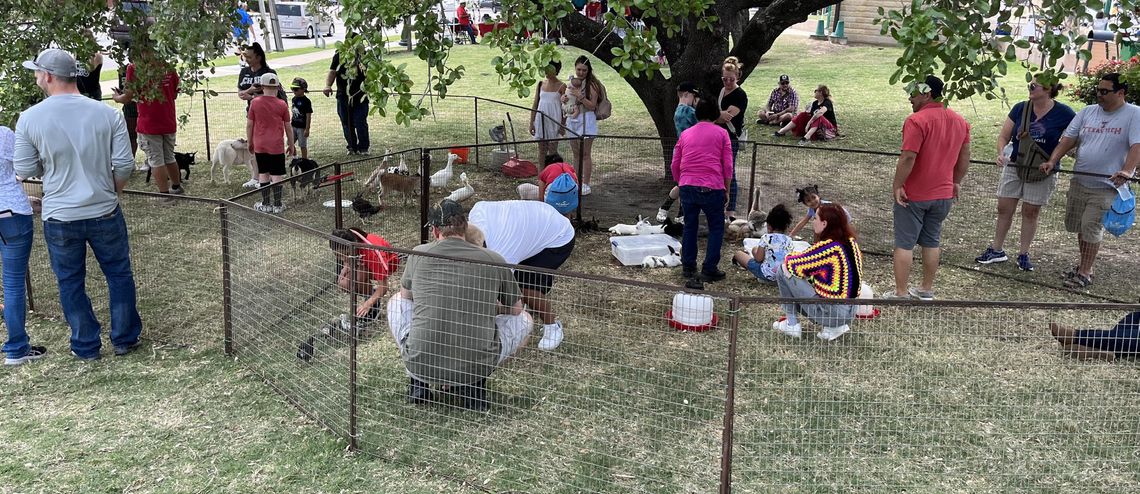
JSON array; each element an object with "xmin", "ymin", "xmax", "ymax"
[{"xmin": 0, "ymin": 214, "xmax": 34, "ymax": 358}]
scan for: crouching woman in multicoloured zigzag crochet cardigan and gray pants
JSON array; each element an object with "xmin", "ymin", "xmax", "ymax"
[{"xmin": 772, "ymin": 203, "xmax": 863, "ymax": 341}]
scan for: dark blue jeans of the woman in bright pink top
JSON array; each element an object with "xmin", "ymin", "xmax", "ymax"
[{"xmin": 681, "ymin": 185, "xmax": 725, "ymax": 273}]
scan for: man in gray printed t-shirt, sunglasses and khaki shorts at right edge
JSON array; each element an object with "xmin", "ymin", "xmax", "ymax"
[{"xmin": 1041, "ymin": 73, "xmax": 1140, "ymax": 289}]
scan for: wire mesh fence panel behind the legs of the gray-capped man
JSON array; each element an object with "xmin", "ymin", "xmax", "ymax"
[{"xmin": 29, "ymin": 191, "xmax": 222, "ymax": 346}]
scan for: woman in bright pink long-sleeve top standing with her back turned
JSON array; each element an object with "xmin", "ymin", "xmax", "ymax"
[{"xmin": 671, "ymin": 99, "xmax": 733, "ymax": 286}]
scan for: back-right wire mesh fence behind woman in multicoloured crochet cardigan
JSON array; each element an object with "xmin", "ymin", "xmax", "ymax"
[{"xmin": 752, "ymin": 145, "xmax": 1140, "ymax": 302}]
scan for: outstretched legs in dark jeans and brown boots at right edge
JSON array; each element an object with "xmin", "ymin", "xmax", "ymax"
[{"xmin": 1049, "ymin": 311, "xmax": 1140, "ymax": 362}]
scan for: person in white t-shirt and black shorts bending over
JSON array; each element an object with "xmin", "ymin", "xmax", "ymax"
[{"xmin": 466, "ymin": 201, "xmax": 575, "ymax": 351}]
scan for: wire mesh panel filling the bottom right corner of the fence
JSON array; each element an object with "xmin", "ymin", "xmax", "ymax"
[{"xmin": 733, "ymin": 299, "xmax": 1140, "ymax": 492}]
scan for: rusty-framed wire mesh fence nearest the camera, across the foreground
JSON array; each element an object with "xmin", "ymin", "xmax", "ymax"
[{"xmin": 225, "ymin": 204, "xmax": 1140, "ymax": 492}]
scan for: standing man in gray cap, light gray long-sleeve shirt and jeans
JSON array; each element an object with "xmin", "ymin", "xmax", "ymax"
[{"xmin": 13, "ymin": 48, "xmax": 143, "ymax": 361}]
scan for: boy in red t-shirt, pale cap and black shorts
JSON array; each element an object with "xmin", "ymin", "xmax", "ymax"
[{"xmin": 245, "ymin": 72, "xmax": 296, "ymax": 214}]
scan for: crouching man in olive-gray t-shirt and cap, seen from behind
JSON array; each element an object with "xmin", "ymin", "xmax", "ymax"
[{"xmin": 388, "ymin": 200, "xmax": 534, "ymax": 411}]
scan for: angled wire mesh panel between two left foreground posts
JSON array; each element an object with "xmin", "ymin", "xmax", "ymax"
[{"xmin": 227, "ymin": 203, "xmax": 351, "ymax": 436}]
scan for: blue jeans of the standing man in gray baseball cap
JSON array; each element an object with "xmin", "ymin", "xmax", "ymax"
[{"xmin": 43, "ymin": 206, "xmax": 143, "ymax": 358}]
